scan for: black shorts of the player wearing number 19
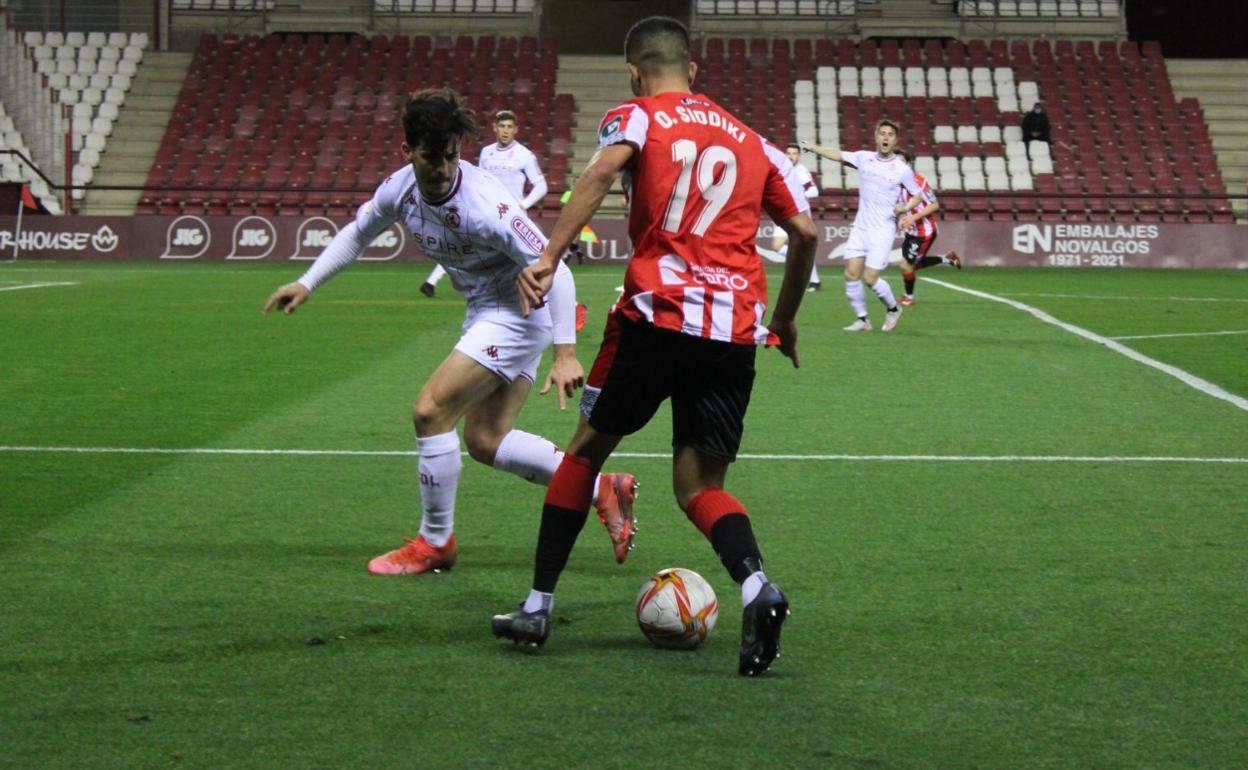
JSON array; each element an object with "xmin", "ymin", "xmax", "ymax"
[{"xmin": 580, "ymin": 312, "xmax": 758, "ymax": 462}]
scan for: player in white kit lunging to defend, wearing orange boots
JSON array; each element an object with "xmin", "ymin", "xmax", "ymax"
[{"xmin": 265, "ymin": 89, "xmax": 635, "ymax": 575}]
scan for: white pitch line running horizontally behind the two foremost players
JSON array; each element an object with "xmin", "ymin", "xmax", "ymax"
[{"xmin": 0, "ymin": 446, "xmax": 1248, "ymax": 464}]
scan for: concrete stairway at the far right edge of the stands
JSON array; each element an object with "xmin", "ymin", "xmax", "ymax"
[{"xmin": 1166, "ymin": 59, "xmax": 1248, "ymax": 223}]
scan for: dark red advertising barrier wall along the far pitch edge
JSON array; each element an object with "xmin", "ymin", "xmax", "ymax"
[{"xmin": 0, "ymin": 215, "xmax": 1248, "ymax": 268}]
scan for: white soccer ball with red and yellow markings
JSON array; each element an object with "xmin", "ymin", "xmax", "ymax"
[{"xmin": 636, "ymin": 567, "xmax": 719, "ymax": 650}]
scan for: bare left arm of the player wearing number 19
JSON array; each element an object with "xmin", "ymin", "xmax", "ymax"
[{"xmin": 515, "ymin": 145, "xmax": 635, "ymax": 316}]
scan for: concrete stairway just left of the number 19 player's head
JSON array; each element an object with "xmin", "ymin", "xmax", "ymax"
[{"xmin": 555, "ymin": 54, "xmax": 633, "ymax": 216}]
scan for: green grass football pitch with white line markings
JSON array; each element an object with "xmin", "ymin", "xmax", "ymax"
[{"xmin": 0, "ymin": 262, "xmax": 1248, "ymax": 769}]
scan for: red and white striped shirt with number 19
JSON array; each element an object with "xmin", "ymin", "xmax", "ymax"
[{"xmin": 598, "ymin": 92, "xmax": 810, "ymax": 344}]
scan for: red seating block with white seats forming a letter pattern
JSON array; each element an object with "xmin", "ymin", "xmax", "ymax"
[{"xmin": 698, "ymin": 37, "xmax": 1233, "ymax": 222}]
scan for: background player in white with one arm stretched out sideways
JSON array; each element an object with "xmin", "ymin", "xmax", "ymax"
[{"xmin": 802, "ymin": 119, "xmax": 920, "ymax": 332}]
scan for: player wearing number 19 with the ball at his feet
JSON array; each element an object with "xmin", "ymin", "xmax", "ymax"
[{"xmin": 492, "ymin": 16, "xmax": 816, "ymax": 675}]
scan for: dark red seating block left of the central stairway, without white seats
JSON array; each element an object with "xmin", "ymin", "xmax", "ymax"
[{"xmin": 137, "ymin": 34, "xmax": 574, "ymax": 216}]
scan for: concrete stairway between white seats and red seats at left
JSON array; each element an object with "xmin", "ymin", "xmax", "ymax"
[{"xmin": 79, "ymin": 51, "xmax": 191, "ymax": 215}]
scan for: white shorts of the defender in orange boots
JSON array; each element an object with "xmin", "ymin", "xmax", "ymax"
[{"xmin": 456, "ymin": 307, "xmax": 554, "ymax": 383}]
